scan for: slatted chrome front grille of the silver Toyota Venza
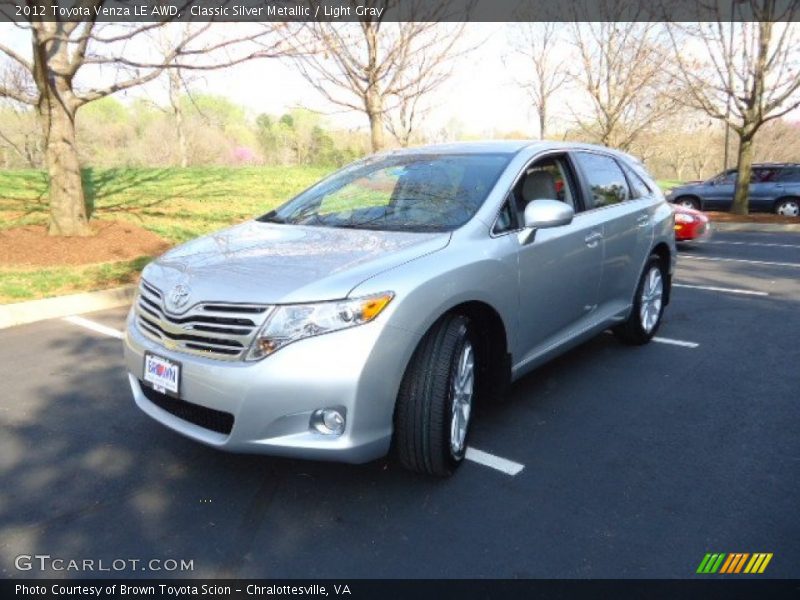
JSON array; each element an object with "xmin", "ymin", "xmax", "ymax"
[{"xmin": 136, "ymin": 280, "xmax": 270, "ymax": 360}]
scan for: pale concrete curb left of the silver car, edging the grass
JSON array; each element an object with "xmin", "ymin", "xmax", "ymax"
[{"xmin": 0, "ymin": 285, "xmax": 136, "ymax": 329}]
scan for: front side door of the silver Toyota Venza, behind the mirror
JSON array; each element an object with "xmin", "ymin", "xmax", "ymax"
[{"xmin": 513, "ymin": 153, "xmax": 603, "ymax": 363}]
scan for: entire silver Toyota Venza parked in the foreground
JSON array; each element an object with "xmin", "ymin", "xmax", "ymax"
[{"xmin": 124, "ymin": 141, "xmax": 675, "ymax": 475}]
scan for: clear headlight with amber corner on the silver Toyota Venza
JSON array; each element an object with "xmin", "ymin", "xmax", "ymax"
[{"xmin": 246, "ymin": 292, "xmax": 394, "ymax": 360}]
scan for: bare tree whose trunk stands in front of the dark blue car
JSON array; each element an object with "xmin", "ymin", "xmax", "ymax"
[{"xmin": 669, "ymin": 0, "xmax": 800, "ymax": 215}]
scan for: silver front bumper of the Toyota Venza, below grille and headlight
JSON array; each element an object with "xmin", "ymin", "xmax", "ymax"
[{"xmin": 124, "ymin": 314, "xmax": 419, "ymax": 463}]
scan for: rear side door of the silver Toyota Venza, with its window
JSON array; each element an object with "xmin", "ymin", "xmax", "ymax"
[{"xmin": 575, "ymin": 151, "xmax": 656, "ymax": 318}]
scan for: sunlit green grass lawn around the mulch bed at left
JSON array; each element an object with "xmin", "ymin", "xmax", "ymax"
[{"xmin": 0, "ymin": 167, "xmax": 331, "ymax": 303}]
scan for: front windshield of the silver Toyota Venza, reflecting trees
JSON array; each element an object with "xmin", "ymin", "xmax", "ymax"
[{"xmin": 258, "ymin": 154, "xmax": 511, "ymax": 231}]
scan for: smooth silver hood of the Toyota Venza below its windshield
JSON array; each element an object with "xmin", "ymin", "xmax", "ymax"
[{"xmin": 142, "ymin": 221, "xmax": 450, "ymax": 305}]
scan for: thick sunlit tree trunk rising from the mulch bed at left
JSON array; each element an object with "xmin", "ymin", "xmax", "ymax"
[{"xmin": 39, "ymin": 97, "xmax": 92, "ymax": 237}]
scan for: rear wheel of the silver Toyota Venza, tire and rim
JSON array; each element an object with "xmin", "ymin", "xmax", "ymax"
[{"xmin": 613, "ymin": 254, "xmax": 667, "ymax": 345}]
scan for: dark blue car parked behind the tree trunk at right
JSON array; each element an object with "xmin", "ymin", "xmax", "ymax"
[{"xmin": 667, "ymin": 163, "xmax": 800, "ymax": 217}]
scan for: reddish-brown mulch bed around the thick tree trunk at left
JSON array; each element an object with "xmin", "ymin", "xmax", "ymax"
[{"xmin": 0, "ymin": 221, "xmax": 170, "ymax": 267}]
